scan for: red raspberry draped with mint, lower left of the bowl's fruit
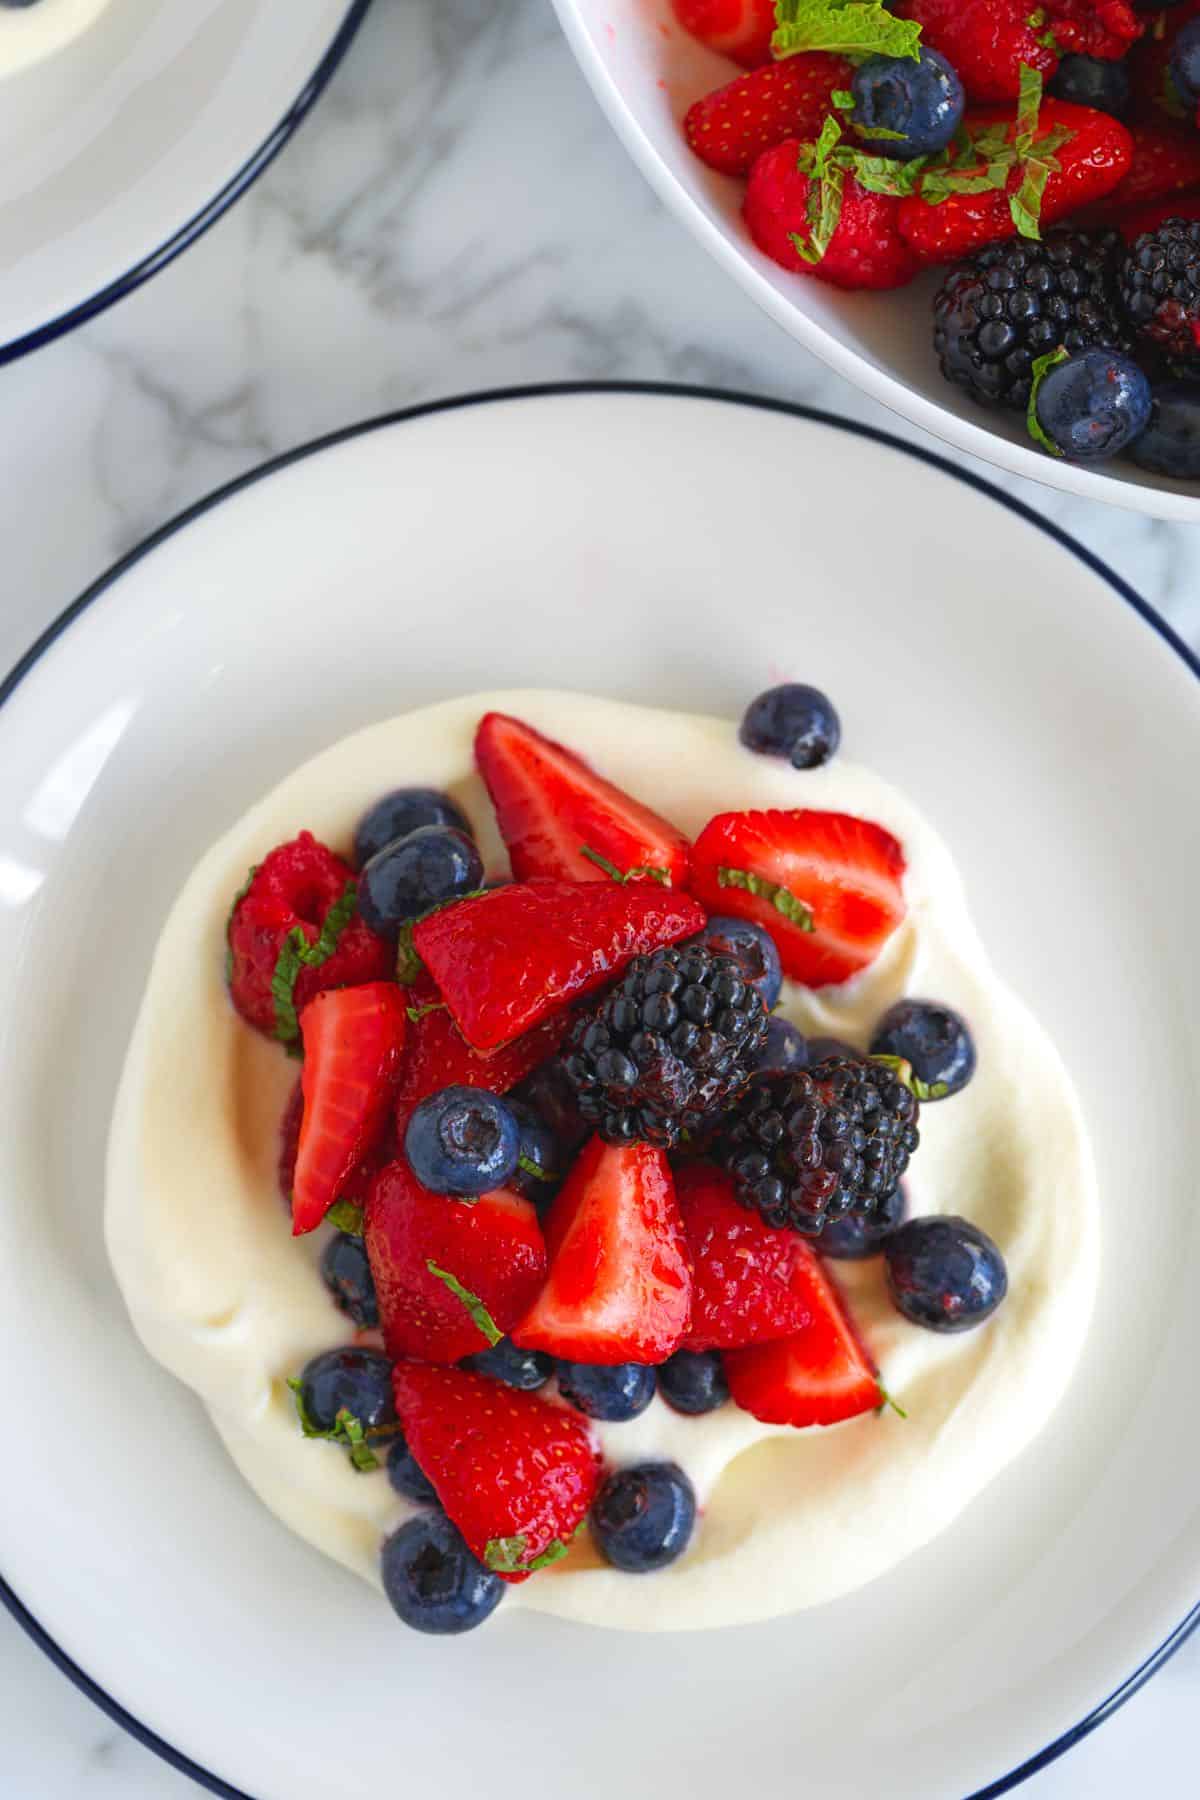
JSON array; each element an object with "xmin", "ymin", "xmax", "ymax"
[{"xmin": 743, "ymin": 139, "xmax": 918, "ymax": 288}]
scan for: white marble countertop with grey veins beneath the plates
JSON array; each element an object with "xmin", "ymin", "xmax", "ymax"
[{"xmin": 0, "ymin": 0, "xmax": 1200, "ymax": 1800}]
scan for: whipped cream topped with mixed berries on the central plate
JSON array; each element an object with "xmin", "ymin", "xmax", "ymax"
[{"xmin": 106, "ymin": 684, "xmax": 1096, "ymax": 1634}]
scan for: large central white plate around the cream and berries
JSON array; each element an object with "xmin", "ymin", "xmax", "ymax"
[{"xmin": 0, "ymin": 391, "xmax": 1200, "ymax": 1800}]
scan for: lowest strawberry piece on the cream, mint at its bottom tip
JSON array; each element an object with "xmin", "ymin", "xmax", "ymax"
[{"xmin": 392, "ymin": 1363, "xmax": 601, "ymax": 1582}]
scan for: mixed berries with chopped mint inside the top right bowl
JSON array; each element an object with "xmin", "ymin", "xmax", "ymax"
[{"xmin": 673, "ymin": 0, "xmax": 1200, "ymax": 481}]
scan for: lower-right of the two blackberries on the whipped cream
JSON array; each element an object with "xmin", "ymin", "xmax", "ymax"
[{"xmin": 720, "ymin": 1057, "xmax": 918, "ymax": 1237}]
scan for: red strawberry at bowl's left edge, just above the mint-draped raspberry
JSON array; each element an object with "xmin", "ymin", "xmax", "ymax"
[{"xmin": 684, "ymin": 50, "xmax": 855, "ymax": 175}]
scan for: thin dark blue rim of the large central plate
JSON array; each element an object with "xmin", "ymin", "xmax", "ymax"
[{"xmin": 0, "ymin": 387, "xmax": 1200, "ymax": 1800}]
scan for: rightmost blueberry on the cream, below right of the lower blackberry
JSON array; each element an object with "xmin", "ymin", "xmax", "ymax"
[{"xmin": 883, "ymin": 1217, "xmax": 1007, "ymax": 1332}]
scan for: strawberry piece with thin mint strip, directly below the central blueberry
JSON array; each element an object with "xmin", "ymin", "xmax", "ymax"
[{"xmin": 363, "ymin": 1157, "xmax": 545, "ymax": 1363}]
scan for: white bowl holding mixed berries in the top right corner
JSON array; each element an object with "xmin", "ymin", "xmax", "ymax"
[{"xmin": 554, "ymin": 0, "xmax": 1200, "ymax": 524}]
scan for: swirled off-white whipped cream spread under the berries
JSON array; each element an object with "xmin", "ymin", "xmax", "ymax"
[{"xmin": 106, "ymin": 691, "xmax": 1097, "ymax": 1631}]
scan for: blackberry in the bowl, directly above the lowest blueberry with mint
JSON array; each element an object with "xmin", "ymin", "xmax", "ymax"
[{"xmin": 934, "ymin": 230, "xmax": 1128, "ymax": 412}]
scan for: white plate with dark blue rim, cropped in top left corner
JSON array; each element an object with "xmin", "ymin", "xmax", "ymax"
[{"xmin": 0, "ymin": 0, "xmax": 371, "ymax": 362}]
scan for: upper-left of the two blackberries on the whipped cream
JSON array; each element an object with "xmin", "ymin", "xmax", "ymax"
[{"xmin": 563, "ymin": 943, "xmax": 766, "ymax": 1150}]
